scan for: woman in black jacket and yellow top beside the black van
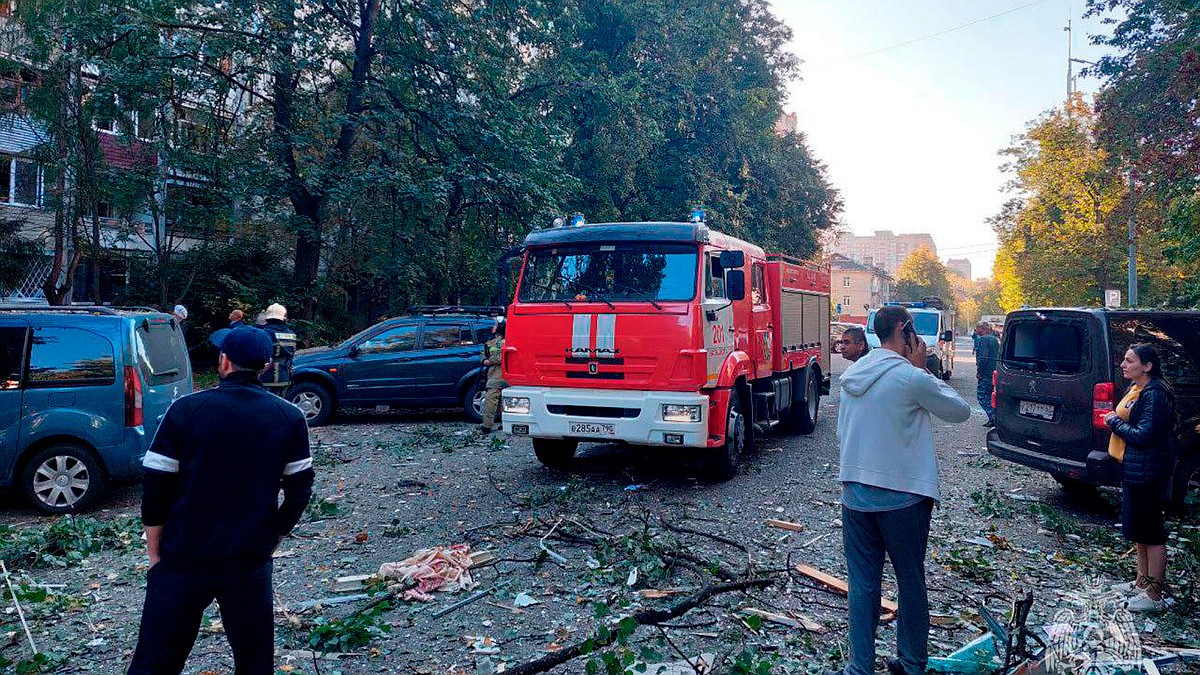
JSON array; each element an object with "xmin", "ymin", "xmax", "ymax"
[{"xmin": 1104, "ymin": 345, "xmax": 1176, "ymax": 611}]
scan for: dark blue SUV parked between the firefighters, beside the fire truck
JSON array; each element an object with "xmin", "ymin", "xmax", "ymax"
[{"xmin": 288, "ymin": 307, "xmax": 503, "ymax": 426}]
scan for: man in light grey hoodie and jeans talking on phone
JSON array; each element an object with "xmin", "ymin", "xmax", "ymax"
[{"xmin": 838, "ymin": 306, "xmax": 971, "ymax": 675}]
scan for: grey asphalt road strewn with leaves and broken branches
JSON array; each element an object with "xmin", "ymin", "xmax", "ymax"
[{"xmin": 6, "ymin": 341, "xmax": 1200, "ymax": 675}]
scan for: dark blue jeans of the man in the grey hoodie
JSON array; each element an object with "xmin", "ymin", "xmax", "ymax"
[{"xmin": 841, "ymin": 500, "xmax": 934, "ymax": 675}]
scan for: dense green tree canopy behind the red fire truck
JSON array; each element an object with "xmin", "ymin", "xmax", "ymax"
[{"xmin": 4, "ymin": 0, "xmax": 841, "ymax": 327}]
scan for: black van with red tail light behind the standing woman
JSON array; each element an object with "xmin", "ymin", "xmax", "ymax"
[{"xmin": 988, "ymin": 309, "xmax": 1200, "ymax": 508}]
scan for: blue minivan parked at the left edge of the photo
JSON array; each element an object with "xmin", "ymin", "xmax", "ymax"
[{"xmin": 0, "ymin": 305, "xmax": 192, "ymax": 513}]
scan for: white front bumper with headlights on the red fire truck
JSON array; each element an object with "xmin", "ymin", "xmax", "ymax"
[{"xmin": 502, "ymin": 387, "xmax": 708, "ymax": 448}]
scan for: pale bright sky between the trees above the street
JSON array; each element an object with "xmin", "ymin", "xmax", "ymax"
[{"xmin": 773, "ymin": 0, "xmax": 1106, "ymax": 279}]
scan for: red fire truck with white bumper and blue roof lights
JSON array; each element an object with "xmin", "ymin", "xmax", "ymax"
[{"xmin": 503, "ymin": 210, "xmax": 829, "ymax": 479}]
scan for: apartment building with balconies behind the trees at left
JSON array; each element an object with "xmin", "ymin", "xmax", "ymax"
[{"xmin": 0, "ymin": 6, "xmax": 241, "ymax": 303}]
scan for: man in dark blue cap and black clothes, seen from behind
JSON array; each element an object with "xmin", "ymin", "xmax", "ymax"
[{"xmin": 128, "ymin": 327, "xmax": 313, "ymax": 675}]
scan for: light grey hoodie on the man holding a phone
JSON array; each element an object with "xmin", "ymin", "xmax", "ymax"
[{"xmin": 838, "ymin": 348, "xmax": 971, "ymax": 500}]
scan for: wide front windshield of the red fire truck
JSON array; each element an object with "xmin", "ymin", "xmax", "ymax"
[{"xmin": 518, "ymin": 241, "xmax": 697, "ymax": 303}]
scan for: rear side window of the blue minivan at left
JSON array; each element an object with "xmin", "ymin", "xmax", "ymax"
[{"xmin": 29, "ymin": 328, "xmax": 116, "ymax": 387}]
